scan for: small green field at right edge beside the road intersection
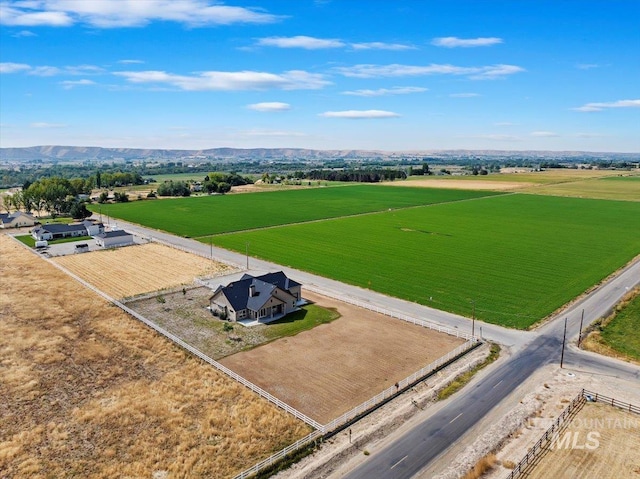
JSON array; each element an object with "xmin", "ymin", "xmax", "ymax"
[{"xmin": 601, "ymin": 294, "xmax": 640, "ymax": 361}]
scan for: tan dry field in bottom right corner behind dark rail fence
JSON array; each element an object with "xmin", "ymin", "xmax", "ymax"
[{"xmin": 521, "ymin": 403, "xmax": 640, "ymax": 479}]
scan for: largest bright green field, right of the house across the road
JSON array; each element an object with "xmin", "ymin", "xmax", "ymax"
[{"xmin": 213, "ymin": 190, "xmax": 640, "ymax": 328}]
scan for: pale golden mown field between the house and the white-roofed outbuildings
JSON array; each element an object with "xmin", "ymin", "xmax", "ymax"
[{"xmin": 54, "ymin": 243, "xmax": 233, "ymax": 298}]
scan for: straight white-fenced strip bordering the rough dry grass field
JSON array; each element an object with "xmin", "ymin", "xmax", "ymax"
[{"xmin": 44, "ymin": 258, "xmax": 323, "ymax": 431}]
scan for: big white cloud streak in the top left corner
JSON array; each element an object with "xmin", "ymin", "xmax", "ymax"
[{"xmin": 0, "ymin": 0, "xmax": 282, "ymax": 28}]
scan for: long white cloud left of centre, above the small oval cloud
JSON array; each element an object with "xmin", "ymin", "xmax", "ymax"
[{"xmin": 114, "ymin": 70, "xmax": 331, "ymax": 91}]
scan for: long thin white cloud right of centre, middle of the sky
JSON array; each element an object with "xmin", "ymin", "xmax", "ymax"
[{"xmin": 336, "ymin": 63, "xmax": 525, "ymax": 80}]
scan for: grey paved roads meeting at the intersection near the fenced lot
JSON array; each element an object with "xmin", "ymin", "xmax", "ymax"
[{"xmin": 101, "ymin": 216, "xmax": 640, "ymax": 479}]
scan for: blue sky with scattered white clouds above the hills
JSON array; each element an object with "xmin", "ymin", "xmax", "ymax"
[{"xmin": 0, "ymin": 0, "xmax": 640, "ymax": 152}]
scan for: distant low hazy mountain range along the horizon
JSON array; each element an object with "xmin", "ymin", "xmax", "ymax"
[{"xmin": 0, "ymin": 146, "xmax": 640, "ymax": 162}]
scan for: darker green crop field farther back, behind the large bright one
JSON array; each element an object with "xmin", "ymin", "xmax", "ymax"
[{"xmin": 89, "ymin": 185, "xmax": 497, "ymax": 238}]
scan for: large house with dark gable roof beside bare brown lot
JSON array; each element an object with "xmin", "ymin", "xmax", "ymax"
[{"xmin": 209, "ymin": 271, "xmax": 302, "ymax": 322}]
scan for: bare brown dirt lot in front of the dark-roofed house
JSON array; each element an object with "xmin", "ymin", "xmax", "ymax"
[{"xmin": 220, "ymin": 292, "xmax": 464, "ymax": 424}]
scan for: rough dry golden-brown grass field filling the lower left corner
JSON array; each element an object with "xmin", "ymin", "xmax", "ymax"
[{"xmin": 0, "ymin": 234, "xmax": 309, "ymax": 478}]
